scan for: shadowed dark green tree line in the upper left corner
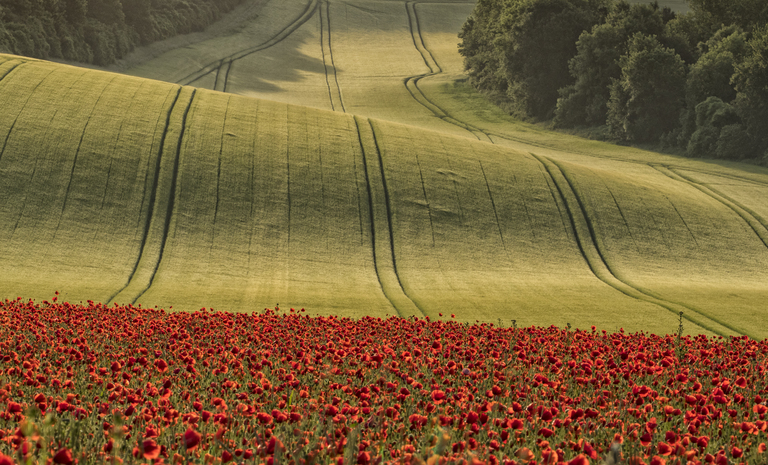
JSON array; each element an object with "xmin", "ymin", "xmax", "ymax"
[{"xmin": 0, "ymin": 0, "xmax": 243, "ymax": 66}]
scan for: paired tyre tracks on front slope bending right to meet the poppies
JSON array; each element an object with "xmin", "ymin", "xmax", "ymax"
[{"xmin": 531, "ymin": 153, "xmax": 754, "ymax": 338}]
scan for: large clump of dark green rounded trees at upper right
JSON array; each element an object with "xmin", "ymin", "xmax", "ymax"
[{"xmin": 459, "ymin": 0, "xmax": 768, "ymax": 160}]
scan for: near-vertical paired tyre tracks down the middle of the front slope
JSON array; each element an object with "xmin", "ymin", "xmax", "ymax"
[{"xmin": 354, "ymin": 116, "xmax": 424, "ymax": 318}]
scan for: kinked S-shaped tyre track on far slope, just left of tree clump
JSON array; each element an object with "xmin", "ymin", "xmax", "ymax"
[{"xmin": 403, "ymin": 1, "xmax": 493, "ymax": 143}]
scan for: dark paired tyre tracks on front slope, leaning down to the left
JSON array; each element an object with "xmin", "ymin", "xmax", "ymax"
[{"xmin": 107, "ymin": 86, "xmax": 197, "ymax": 303}]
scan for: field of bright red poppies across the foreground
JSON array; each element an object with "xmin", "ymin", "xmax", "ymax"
[{"xmin": 0, "ymin": 297, "xmax": 768, "ymax": 465}]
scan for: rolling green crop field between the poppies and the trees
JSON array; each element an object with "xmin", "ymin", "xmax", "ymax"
[{"xmin": 0, "ymin": 1, "xmax": 768, "ymax": 337}]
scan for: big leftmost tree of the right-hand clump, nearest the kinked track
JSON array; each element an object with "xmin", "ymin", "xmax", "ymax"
[{"xmin": 459, "ymin": 0, "xmax": 609, "ymax": 119}]
